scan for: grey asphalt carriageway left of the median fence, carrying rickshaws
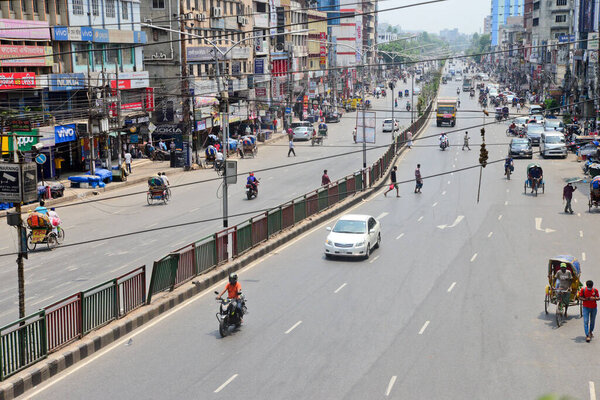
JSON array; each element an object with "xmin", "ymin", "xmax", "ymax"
[{"xmin": 0, "ymin": 87, "xmax": 410, "ymax": 326}]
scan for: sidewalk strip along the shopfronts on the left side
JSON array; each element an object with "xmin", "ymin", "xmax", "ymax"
[{"xmin": 0, "ymin": 131, "xmax": 287, "ymax": 217}]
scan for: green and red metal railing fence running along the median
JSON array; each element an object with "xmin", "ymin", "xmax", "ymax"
[{"xmin": 0, "ymin": 103, "xmax": 432, "ymax": 381}]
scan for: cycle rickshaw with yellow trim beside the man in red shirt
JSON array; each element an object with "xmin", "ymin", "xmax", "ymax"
[{"xmin": 544, "ymin": 255, "xmax": 583, "ymax": 327}]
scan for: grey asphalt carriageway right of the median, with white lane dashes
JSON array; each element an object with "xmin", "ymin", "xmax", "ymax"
[{"xmin": 18, "ymin": 64, "xmax": 600, "ymax": 399}]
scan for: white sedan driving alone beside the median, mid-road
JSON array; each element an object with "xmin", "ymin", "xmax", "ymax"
[{"xmin": 325, "ymin": 214, "xmax": 381, "ymax": 259}]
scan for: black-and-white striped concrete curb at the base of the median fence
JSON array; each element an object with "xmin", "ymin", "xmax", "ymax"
[{"xmin": 0, "ymin": 109, "xmax": 428, "ymax": 400}]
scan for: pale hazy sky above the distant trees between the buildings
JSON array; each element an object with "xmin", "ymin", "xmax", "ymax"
[{"xmin": 379, "ymin": 0, "xmax": 491, "ymax": 33}]
